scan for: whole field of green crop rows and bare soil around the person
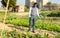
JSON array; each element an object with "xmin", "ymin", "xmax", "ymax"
[{"xmin": 0, "ymin": 11, "xmax": 60, "ymax": 38}]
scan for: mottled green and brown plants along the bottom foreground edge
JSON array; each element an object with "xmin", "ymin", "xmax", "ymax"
[{"xmin": 0, "ymin": 30, "xmax": 60, "ymax": 38}]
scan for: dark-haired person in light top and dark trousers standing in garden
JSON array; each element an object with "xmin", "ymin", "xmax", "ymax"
[{"xmin": 28, "ymin": 3, "xmax": 39, "ymax": 33}]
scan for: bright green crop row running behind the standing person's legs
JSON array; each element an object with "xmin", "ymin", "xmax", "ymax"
[{"xmin": 6, "ymin": 19, "xmax": 60, "ymax": 32}]
